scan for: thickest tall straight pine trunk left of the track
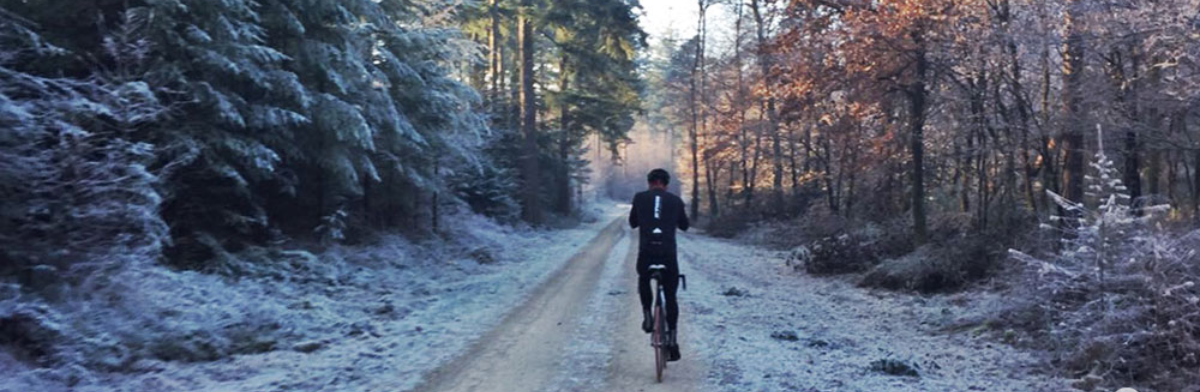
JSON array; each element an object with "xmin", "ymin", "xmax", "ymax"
[{"xmin": 517, "ymin": 8, "xmax": 541, "ymax": 223}]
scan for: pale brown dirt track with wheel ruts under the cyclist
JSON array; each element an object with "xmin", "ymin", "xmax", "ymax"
[{"xmin": 416, "ymin": 219, "xmax": 704, "ymax": 392}]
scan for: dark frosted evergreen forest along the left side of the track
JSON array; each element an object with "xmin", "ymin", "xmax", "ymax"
[{"xmin": 2, "ymin": 0, "xmax": 644, "ymax": 269}]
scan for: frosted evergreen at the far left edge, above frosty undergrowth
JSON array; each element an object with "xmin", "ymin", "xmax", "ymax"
[{"xmin": 0, "ymin": 8, "xmax": 168, "ymax": 270}]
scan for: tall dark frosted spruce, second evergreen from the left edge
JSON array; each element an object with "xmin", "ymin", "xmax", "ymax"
[{"xmin": 137, "ymin": 0, "xmax": 313, "ymax": 265}]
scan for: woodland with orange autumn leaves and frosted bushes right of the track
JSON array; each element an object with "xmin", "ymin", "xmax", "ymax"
[{"xmin": 648, "ymin": 0, "xmax": 1200, "ymax": 390}]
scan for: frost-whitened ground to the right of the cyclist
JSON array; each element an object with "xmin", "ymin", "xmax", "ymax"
[{"xmin": 679, "ymin": 235, "xmax": 1069, "ymax": 392}]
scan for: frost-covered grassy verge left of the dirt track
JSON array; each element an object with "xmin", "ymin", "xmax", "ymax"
[{"xmin": 0, "ymin": 205, "xmax": 623, "ymax": 392}]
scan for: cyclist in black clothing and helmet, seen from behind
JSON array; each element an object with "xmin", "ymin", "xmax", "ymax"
[{"xmin": 629, "ymin": 169, "xmax": 689, "ymax": 361}]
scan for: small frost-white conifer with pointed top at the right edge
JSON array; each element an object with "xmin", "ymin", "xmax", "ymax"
[{"xmin": 1010, "ymin": 130, "xmax": 1200, "ymax": 390}]
